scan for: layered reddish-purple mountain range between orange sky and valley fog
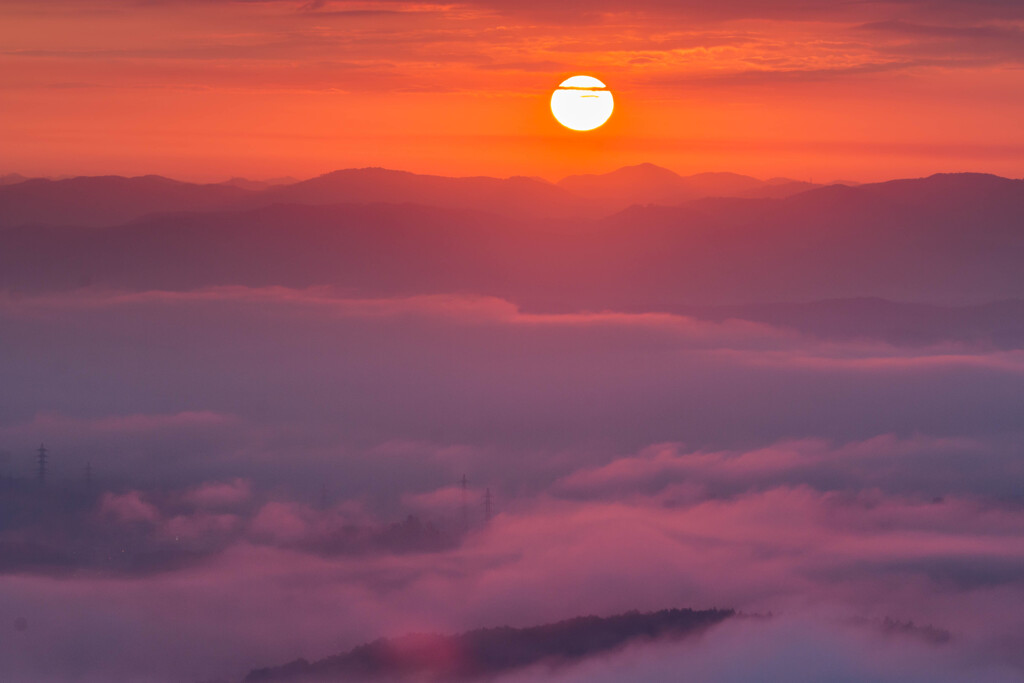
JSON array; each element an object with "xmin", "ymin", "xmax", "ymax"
[{"xmin": 0, "ymin": 165, "xmax": 1024, "ymax": 310}]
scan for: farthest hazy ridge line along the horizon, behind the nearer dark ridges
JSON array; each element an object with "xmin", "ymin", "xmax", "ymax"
[{"xmin": 0, "ymin": 164, "xmax": 823, "ymax": 228}]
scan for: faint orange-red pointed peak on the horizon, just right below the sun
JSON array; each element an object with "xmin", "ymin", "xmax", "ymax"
[{"xmin": 557, "ymin": 164, "xmax": 818, "ymax": 211}]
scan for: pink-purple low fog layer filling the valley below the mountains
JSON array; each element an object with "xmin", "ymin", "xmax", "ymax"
[{"xmin": 0, "ymin": 287, "xmax": 1024, "ymax": 681}]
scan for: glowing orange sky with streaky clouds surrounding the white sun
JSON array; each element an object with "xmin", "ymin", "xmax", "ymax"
[{"xmin": 0, "ymin": 0, "xmax": 1024, "ymax": 181}]
